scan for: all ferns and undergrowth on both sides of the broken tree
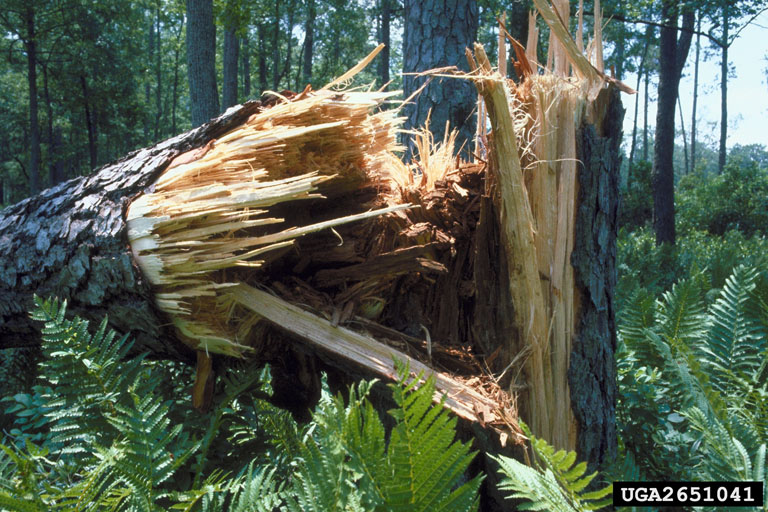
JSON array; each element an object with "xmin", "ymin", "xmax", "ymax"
[{"xmin": 0, "ymin": 150, "xmax": 768, "ymax": 511}]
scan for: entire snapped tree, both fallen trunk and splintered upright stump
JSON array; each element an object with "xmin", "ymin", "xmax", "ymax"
[{"xmin": 0, "ymin": 0, "xmax": 622, "ymax": 474}]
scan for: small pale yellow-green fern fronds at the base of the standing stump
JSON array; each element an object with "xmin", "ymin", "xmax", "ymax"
[{"xmin": 494, "ymin": 424, "xmax": 613, "ymax": 512}]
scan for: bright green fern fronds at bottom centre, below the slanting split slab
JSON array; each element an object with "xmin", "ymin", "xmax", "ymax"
[{"xmin": 288, "ymin": 362, "xmax": 481, "ymax": 511}]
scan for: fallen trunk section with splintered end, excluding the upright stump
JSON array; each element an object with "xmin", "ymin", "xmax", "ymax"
[{"xmin": 0, "ymin": 60, "xmax": 521, "ymax": 443}]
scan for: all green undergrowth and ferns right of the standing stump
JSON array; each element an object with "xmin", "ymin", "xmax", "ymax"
[{"xmin": 612, "ymin": 150, "xmax": 768, "ymax": 502}]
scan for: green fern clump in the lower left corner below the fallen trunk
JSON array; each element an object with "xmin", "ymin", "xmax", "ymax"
[{"xmin": 0, "ymin": 297, "xmax": 197, "ymax": 511}]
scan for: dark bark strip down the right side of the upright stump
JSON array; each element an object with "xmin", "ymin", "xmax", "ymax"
[{"xmin": 568, "ymin": 88, "xmax": 624, "ymax": 470}]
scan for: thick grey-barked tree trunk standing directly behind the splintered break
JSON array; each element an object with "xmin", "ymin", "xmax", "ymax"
[{"xmin": 403, "ymin": 0, "xmax": 478, "ymax": 157}]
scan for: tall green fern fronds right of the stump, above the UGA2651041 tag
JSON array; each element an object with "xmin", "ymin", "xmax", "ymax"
[{"xmin": 617, "ymin": 266, "xmax": 768, "ymax": 481}]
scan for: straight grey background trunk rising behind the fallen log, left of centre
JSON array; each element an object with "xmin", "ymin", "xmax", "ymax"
[{"xmin": 187, "ymin": 0, "xmax": 219, "ymax": 126}]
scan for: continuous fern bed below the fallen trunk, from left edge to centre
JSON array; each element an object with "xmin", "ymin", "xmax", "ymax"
[{"xmin": 0, "ymin": 297, "xmax": 482, "ymax": 512}]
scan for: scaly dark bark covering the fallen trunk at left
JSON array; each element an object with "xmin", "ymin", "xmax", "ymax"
[{"xmin": 0, "ymin": 102, "xmax": 260, "ymax": 359}]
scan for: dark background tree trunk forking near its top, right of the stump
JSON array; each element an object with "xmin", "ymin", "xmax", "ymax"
[{"xmin": 653, "ymin": 0, "xmax": 695, "ymax": 244}]
